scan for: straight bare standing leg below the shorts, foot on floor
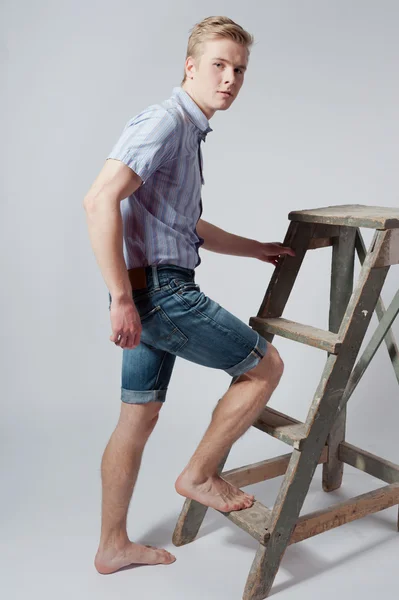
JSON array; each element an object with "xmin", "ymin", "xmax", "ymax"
[{"xmin": 94, "ymin": 402, "xmax": 175, "ymax": 574}]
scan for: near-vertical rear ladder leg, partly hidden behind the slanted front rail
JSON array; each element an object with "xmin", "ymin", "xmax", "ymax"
[{"xmin": 323, "ymin": 227, "xmax": 357, "ymax": 492}]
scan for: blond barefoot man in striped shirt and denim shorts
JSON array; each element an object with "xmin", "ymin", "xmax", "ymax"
[{"xmin": 84, "ymin": 17, "xmax": 294, "ymax": 573}]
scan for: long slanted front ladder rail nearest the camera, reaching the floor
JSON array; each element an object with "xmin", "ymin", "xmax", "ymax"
[{"xmin": 244, "ymin": 231, "xmax": 389, "ymax": 600}]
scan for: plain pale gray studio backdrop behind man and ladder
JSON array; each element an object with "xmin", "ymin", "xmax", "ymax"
[{"xmin": 0, "ymin": 0, "xmax": 399, "ymax": 599}]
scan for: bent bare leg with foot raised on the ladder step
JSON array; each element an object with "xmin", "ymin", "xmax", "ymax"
[{"xmin": 176, "ymin": 344, "xmax": 283, "ymax": 512}]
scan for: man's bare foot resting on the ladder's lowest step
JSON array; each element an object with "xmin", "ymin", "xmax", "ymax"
[{"xmin": 175, "ymin": 471, "xmax": 255, "ymax": 512}]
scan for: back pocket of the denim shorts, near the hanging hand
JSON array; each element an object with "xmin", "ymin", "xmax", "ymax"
[{"xmin": 139, "ymin": 305, "xmax": 188, "ymax": 354}]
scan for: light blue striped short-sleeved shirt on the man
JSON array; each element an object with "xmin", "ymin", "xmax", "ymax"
[{"xmin": 107, "ymin": 87, "xmax": 212, "ymax": 269}]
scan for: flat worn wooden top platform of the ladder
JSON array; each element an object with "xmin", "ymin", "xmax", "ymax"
[{"xmin": 288, "ymin": 204, "xmax": 399, "ymax": 229}]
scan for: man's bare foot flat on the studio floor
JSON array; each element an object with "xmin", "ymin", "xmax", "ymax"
[{"xmin": 94, "ymin": 542, "xmax": 176, "ymax": 575}]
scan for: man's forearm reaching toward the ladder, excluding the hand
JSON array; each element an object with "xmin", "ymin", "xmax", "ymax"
[{"xmin": 196, "ymin": 219, "xmax": 259, "ymax": 257}]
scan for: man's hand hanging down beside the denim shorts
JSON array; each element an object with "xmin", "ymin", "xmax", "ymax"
[{"xmin": 109, "ymin": 298, "xmax": 142, "ymax": 349}]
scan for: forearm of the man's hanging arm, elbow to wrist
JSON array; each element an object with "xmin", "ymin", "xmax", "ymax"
[{"xmin": 84, "ymin": 196, "xmax": 132, "ymax": 300}]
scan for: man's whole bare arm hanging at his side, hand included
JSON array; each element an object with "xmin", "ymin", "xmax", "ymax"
[{"xmin": 83, "ymin": 159, "xmax": 142, "ymax": 348}]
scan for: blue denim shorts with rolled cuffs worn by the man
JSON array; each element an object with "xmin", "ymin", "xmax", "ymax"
[{"xmin": 109, "ymin": 264, "xmax": 268, "ymax": 404}]
